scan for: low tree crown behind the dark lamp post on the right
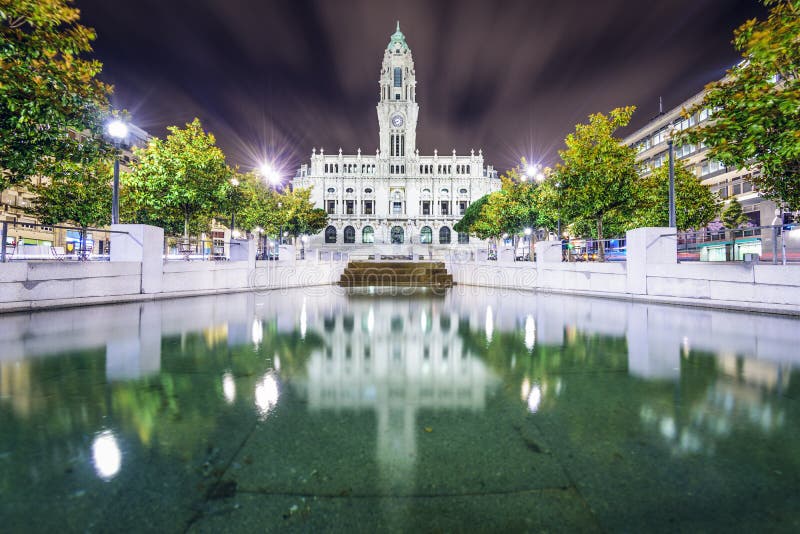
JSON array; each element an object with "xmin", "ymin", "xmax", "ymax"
[{"xmin": 629, "ymin": 164, "xmax": 721, "ymax": 230}]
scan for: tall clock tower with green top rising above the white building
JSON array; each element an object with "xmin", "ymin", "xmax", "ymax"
[{"xmin": 377, "ymin": 22, "xmax": 419, "ymax": 159}]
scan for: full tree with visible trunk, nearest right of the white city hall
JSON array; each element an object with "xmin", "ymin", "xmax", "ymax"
[{"xmin": 551, "ymin": 106, "xmax": 639, "ymax": 261}]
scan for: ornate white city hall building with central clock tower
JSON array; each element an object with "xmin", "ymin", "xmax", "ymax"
[{"xmin": 292, "ymin": 23, "xmax": 500, "ymax": 247}]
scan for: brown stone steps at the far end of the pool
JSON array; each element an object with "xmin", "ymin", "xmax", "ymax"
[{"xmin": 339, "ymin": 261, "xmax": 453, "ymax": 289}]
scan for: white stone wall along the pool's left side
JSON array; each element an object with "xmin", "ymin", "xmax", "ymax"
[{"xmin": 0, "ymin": 225, "xmax": 345, "ymax": 316}]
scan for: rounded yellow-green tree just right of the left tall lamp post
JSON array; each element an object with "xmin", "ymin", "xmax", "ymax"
[{"xmin": 123, "ymin": 119, "xmax": 233, "ymax": 238}]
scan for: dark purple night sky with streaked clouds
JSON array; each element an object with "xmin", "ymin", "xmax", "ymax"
[{"xmin": 76, "ymin": 0, "xmax": 765, "ymax": 175}]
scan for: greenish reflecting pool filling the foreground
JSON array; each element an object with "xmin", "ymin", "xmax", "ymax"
[{"xmin": 0, "ymin": 287, "xmax": 800, "ymax": 532}]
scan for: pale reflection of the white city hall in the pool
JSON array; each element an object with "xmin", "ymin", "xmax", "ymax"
[{"xmin": 290, "ymin": 297, "xmax": 499, "ymax": 498}]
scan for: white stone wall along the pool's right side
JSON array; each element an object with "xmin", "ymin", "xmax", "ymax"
[{"xmin": 447, "ymin": 228, "xmax": 800, "ymax": 315}]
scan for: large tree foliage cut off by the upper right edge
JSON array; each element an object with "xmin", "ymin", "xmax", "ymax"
[{"xmin": 685, "ymin": 0, "xmax": 800, "ymax": 209}]
